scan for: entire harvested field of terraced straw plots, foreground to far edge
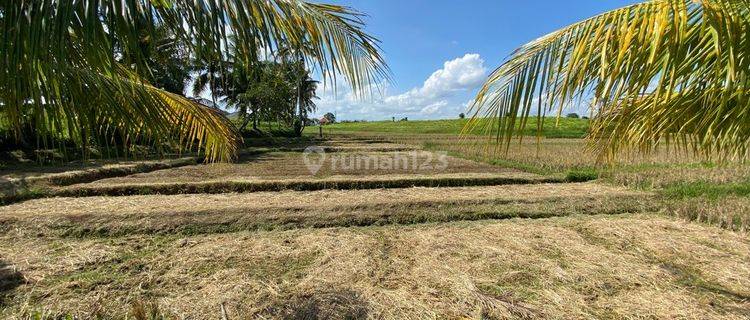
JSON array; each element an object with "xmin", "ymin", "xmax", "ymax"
[{"xmin": 0, "ymin": 132, "xmax": 750, "ymax": 319}]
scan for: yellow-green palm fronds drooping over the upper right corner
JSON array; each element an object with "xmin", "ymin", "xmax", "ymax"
[{"xmin": 465, "ymin": 0, "xmax": 750, "ymax": 161}]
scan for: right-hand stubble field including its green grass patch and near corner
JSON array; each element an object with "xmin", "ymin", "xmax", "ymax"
[{"xmin": 318, "ymin": 131, "xmax": 750, "ymax": 230}]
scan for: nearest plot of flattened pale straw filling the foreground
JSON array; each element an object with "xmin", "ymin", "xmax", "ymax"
[{"xmin": 0, "ymin": 215, "xmax": 750, "ymax": 319}]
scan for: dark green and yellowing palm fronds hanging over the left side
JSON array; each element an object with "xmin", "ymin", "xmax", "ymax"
[{"xmin": 5, "ymin": 0, "xmax": 388, "ymax": 160}]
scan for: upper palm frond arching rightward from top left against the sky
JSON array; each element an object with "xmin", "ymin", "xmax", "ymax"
[{"xmin": 158, "ymin": 0, "xmax": 390, "ymax": 95}]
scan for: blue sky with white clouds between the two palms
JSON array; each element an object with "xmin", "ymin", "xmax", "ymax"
[{"xmin": 317, "ymin": 0, "xmax": 636, "ymax": 120}]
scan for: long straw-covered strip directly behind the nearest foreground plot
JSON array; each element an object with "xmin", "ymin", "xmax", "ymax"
[{"xmin": 0, "ymin": 183, "xmax": 654, "ymax": 237}]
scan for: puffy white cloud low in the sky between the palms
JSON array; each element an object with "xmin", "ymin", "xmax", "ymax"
[{"xmin": 318, "ymin": 53, "xmax": 487, "ymax": 119}]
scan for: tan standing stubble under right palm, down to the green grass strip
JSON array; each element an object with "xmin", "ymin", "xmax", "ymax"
[{"xmin": 329, "ymin": 129, "xmax": 750, "ymax": 188}]
